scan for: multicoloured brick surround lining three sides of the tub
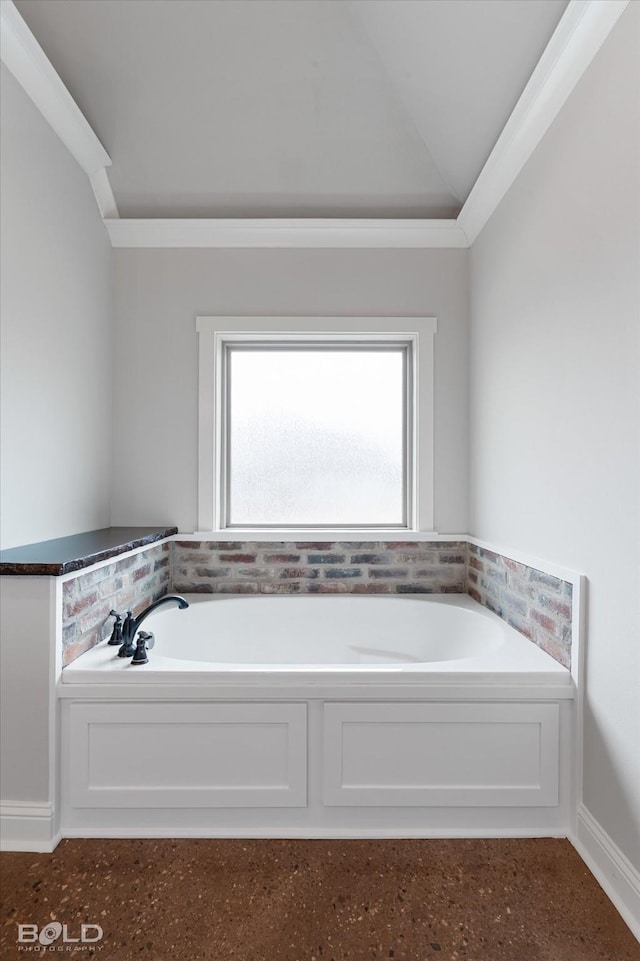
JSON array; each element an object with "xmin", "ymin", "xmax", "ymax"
[{"xmin": 63, "ymin": 540, "xmax": 572, "ymax": 667}]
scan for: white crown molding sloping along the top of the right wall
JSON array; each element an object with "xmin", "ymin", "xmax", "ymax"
[{"xmin": 457, "ymin": 0, "xmax": 629, "ymax": 245}]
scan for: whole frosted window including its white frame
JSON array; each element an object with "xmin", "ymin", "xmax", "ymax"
[{"xmin": 197, "ymin": 317, "xmax": 435, "ymax": 532}]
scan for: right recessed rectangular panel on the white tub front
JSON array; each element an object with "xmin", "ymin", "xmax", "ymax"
[{"xmin": 324, "ymin": 703, "xmax": 558, "ymax": 807}]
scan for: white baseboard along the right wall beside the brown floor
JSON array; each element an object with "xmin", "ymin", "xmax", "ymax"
[{"xmin": 569, "ymin": 804, "xmax": 640, "ymax": 941}]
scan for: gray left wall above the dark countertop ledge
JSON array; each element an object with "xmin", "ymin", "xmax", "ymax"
[{"xmin": 0, "ymin": 66, "xmax": 112, "ymax": 547}]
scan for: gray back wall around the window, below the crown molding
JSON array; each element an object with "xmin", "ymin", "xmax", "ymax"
[{"xmin": 112, "ymin": 250, "xmax": 468, "ymax": 533}]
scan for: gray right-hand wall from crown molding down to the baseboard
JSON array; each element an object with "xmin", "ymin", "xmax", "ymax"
[{"xmin": 470, "ymin": 4, "xmax": 640, "ymax": 868}]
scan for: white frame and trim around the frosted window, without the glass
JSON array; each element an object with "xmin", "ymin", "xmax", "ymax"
[{"xmin": 196, "ymin": 316, "xmax": 437, "ymax": 539}]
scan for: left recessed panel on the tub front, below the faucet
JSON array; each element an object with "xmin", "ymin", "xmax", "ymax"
[{"xmin": 69, "ymin": 703, "xmax": 307, "ymax": 808}]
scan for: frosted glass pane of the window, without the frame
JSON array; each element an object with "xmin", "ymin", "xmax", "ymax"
[{"xmin": 227, "ymin": 347, "xmax": 406, "ymax": 527}]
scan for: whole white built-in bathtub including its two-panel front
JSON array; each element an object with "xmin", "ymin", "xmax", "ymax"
[{"xmin": 57, "ymin": 595, "xmax": 573, "ymax": 837}]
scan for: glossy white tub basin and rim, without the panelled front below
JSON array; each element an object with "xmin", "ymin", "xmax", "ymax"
[{"xmin": 62, "ymin": 594, "xmax": 569, "ymax": 684}]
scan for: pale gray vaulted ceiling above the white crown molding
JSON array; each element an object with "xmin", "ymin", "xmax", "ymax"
[{"xmin": 16, "ymin": 0, "xmax": 567, "ymax": 218}]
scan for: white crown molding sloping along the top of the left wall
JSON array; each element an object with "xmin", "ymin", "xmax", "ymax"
[{"xmin": 0, "ymin": 0, "xmax": 115, "ymax": 210}]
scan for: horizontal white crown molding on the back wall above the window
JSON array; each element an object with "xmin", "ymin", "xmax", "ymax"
[{"xmin": 105, "ymin": 218, "xmax": 468, "ymax": 249}]
